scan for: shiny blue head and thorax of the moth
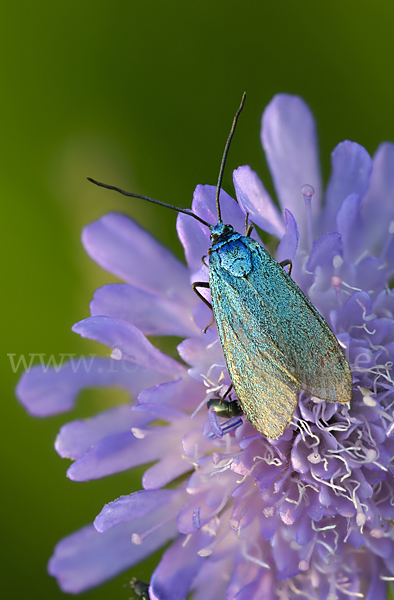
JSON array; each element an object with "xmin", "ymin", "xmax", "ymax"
[{"xmin": 209, "ymin": 223, "xmax": 252, "ymax": 277}]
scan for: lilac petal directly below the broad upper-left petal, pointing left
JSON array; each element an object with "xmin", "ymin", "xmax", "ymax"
[{"xmin": 90, "ymin": 283, "xmax": 198, "ymax": 337}]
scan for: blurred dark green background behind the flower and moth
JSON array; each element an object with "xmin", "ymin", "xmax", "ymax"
[{"xmin": 0, "ymin": 0, "xmax": 394, "ymax": 600}]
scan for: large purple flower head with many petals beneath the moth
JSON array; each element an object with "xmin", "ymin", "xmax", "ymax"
[{"xmin": 17, "ymin": 95, "xmax": 394, "ymax": 600}]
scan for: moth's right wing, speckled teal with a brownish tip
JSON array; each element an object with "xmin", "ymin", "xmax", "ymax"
[{"xmin": 246, "ymin": 240, "xmax": 353, "ymax": 403}]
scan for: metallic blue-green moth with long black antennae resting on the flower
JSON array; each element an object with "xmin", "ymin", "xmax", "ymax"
[{"xmin": 88, "ymin": 94, "xmax": 352, "ymax": 439}]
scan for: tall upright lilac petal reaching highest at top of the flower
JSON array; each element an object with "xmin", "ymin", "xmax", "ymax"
[{"xmin": 261, "ymin": 94, "xmax": 321, "ymax": 246}]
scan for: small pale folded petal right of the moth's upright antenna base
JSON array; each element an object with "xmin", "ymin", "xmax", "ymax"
[{"xmin": 233, "ymin": 166, "xmax": 285, "ymax": 239}]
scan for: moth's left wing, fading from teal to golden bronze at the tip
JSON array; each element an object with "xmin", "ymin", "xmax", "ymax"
[{"xmin": 210, "ymin": 272, "xmax": 300, "ymax": 438}]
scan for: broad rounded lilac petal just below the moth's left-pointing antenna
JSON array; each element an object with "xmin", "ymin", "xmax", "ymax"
[{"xmin": 82, "ymin": 213, "xmax": 193, "ymax": 304}]
